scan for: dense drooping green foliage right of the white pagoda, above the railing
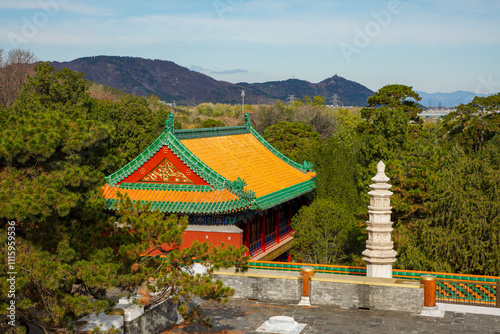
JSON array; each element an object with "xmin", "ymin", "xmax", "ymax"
[{"xmin": 401, "ymin": 145, "xmax": 500, "ymax": 275}]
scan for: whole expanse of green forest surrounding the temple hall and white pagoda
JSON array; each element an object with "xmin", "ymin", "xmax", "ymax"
[{"xmin": 0, "ymin": 55, "xmax": 500, "ymax": 332}]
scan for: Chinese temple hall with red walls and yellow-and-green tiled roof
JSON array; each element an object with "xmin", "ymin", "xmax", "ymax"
[{"xmin": 102, "ymin": 114, "xmax": 316, "ymax": 260}]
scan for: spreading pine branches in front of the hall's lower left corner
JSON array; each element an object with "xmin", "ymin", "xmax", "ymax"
[{"xmin": 111, "ymin": 198, "xmax": 248, "ymax": 325}]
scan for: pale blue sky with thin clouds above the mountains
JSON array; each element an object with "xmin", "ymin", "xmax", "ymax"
[{"xmin": 0, "ymin": 0, "xmax": 500, "ymax": 94}]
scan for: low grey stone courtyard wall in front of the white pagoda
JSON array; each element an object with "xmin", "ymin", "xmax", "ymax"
[{"xmin": 215, "ymin": 269, "xmax": 424, "ymax": 313}]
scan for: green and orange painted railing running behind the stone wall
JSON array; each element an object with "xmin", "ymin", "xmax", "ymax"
[{"xmin": 249, "ymin": 261, "xmax": 500, "ymax": 307}]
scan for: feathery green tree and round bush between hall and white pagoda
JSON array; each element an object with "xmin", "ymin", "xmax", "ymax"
[{"xmin": 292, "ymin": 125, "xmax": 365, "ymax": 264}]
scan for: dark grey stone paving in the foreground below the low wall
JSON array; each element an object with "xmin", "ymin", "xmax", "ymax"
[{"xmin": 163, "ymin": 299, "xmax": 500, "ymax": 334}]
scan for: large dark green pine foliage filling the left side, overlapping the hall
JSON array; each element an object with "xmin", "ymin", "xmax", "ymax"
[{"xmin": 0, "ymin": 63, "xmax": 250, "ymax": 332}]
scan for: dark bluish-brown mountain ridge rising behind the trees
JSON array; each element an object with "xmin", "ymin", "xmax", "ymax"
[{"xmin": 51, "ymin": 56, "xmax": 373, "ymax": 106}]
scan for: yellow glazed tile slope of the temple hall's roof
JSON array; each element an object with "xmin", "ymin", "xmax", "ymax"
[{"xmin": 181, "ymin": 133, "xmax": 316, "ymax": 197}]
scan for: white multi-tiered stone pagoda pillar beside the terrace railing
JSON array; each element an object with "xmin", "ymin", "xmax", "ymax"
[{"xmin": 363, "ymin": 161, "xmax": 397, "ymax": 278}]
